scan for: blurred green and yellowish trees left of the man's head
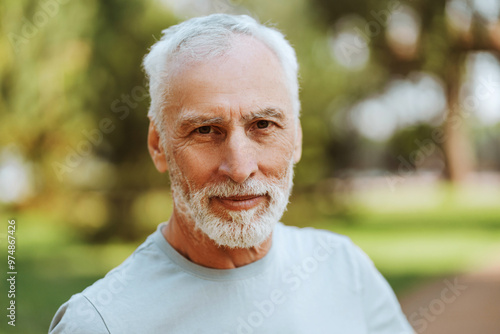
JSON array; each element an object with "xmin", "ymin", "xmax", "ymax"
[{"xmin": 0, "ymin": 0, "xmax": 177, "ymax": 240}]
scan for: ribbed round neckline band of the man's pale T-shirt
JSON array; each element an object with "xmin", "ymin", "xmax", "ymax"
[{"xmin": 153, "ymin": 222, "xmax": 281, "ymax": 281}]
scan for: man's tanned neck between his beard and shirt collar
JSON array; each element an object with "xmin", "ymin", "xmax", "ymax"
[{"xmin": 162, "ymin": 207, "xmax": 272, "ymax": 269}]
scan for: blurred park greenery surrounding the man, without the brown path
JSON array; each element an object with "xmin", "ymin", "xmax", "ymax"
[{"xmin": 0, "ymin": 0, "xmax": 500, "ymax": 333}]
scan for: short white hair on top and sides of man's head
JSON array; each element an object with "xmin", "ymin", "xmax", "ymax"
[{"xmin": 143, "ymin": 14, "xmax": 300, "ymax": 125}]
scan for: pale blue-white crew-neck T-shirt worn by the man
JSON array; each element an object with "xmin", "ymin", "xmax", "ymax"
[{"xmin": 49, "ymin": 223, "xmax": 413, "ymax": 334}]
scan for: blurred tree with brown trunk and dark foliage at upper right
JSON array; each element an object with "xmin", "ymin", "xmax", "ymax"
[{"xmin": 313, "ymin": 0, "xmax": 500, "ymax": 181}]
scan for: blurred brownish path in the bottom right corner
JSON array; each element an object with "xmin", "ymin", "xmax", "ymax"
[{"xmin": 401, "ymin": 262, "xmax": 500, "ymax": 334}]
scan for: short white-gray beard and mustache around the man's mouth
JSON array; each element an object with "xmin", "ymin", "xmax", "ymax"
[{"xmin": 168, "ymin": 159, "xmax": 294, "ymax": 248}]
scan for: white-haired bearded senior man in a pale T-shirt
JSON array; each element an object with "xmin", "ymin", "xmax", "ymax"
[{"xmin": 50, "ymin": 14, "xmax": 413, "ymax": 334}]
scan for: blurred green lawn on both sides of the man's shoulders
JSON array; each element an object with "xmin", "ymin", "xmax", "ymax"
[{"xmin": 0, "ymin": 184, "xmax": 500, "ymax": 333}]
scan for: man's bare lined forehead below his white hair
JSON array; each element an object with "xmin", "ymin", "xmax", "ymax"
[{"xmin": 166, "ymin": 36, "xmax": 293, "ymax": 124}]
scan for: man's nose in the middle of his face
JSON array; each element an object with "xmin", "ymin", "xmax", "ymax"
[{"xmin": 219, "ymin": 130, "xmax": 258, "ymax": 183}]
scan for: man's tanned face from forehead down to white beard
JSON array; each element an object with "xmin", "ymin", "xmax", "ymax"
[{"xmin": 151, "ymin": 37, "xmax": 301, "ymax": 248}]
